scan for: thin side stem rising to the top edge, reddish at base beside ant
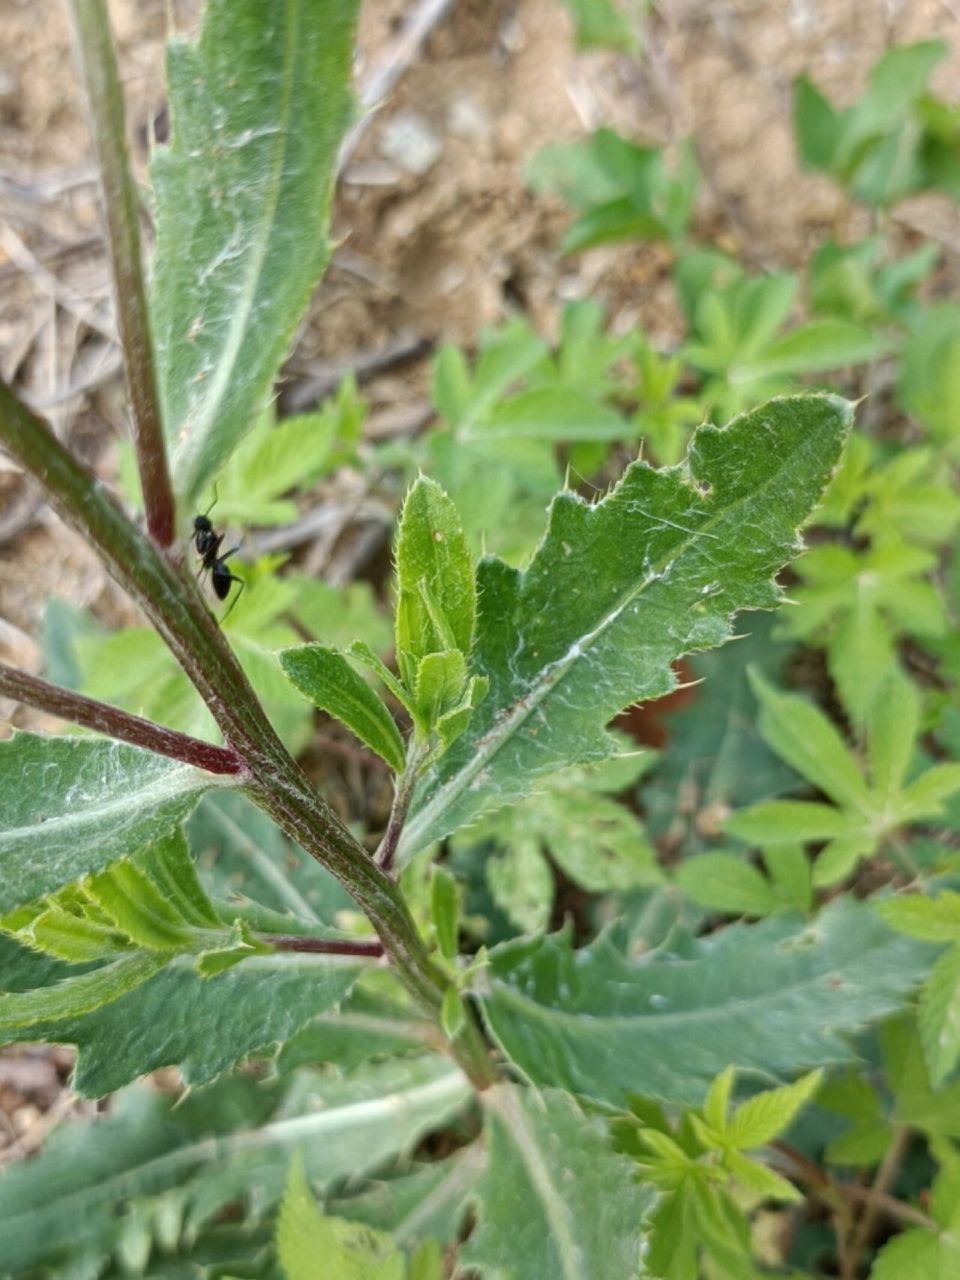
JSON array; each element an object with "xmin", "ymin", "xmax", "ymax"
[{"xmin": 70, "ymin": 0, "xmax": 175, "ymax": 547}]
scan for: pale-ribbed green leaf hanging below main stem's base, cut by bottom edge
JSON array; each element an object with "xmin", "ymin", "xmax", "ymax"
[{"xmin": 460, "ymin": 1084, "xmax": 653, "ymax": 1280}]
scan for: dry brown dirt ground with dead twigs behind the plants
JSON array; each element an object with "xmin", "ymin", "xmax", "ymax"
[{"xmin": 0, "ymin": 0, "xmax": 960, "ymax": 1162}]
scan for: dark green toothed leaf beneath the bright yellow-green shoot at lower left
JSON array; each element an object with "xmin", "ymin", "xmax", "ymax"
[{"xmin": 0, "ymin": 952, "xmax": 362, "ymax": 1097}]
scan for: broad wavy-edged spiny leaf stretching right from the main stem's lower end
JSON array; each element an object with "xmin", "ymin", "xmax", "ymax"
[{"xmin": 481, "ymin": 899, "xmax": 929, "ymax": 1108}]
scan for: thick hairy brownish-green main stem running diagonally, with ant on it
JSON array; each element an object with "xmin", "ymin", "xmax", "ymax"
[{"xmin": 0, "ymin": 381, "xmax": 492, "ymax": 1088}]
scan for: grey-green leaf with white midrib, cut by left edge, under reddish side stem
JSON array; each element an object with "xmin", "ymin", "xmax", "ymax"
[{"xmin": 0, "ymin": 733, "xmax": 229, "ymax": 914}]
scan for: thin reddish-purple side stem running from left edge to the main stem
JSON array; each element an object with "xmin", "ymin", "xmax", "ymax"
[{"xmin": 0, "ymin": 662, "xmax": 246, "ymax": 774}]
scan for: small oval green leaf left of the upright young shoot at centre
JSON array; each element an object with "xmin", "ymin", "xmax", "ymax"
[{"xmin": 278, "ymin": 644, "xmax": 404, "ymax": 773}]
